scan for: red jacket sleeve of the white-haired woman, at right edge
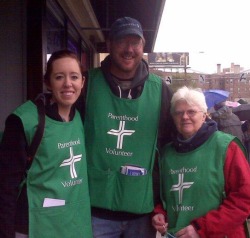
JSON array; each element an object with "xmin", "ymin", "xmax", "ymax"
[{"xmin": 192, "ymin": 142, "xmax": 250, "ymax": 237}]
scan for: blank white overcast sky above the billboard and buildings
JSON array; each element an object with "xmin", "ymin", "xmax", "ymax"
[{"xmin": 154, "ymin": 0, "xmax": 250, "ymax": 73}]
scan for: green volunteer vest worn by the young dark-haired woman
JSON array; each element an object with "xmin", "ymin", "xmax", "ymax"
[{"xmin": 14, "ymin": 101, "xmax": 92, "ymax": 238}]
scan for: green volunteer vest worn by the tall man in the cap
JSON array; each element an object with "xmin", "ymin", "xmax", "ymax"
[{"xmin": 84, "ymin": 69, "xmax": 162, "ymax": 214}]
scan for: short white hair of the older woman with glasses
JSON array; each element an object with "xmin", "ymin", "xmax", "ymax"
[{"xmin": 171, "ymin": 86, "xmax": 207, "ymax": 114}]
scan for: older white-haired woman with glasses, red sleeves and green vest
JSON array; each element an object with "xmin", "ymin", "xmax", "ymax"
[{"xmin": 152, "ymin": 87, "xmax": 250, "ymax": 238}]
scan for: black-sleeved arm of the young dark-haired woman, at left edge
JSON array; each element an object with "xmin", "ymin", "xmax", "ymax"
[{"xmin": 0, "ymin": 115, "xmax": 27, "ymax": 238}]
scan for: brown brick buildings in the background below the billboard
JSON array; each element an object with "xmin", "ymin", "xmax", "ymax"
[{"xmin": 148, "ymin": 61, "xmax": 250, "ymax": 103}]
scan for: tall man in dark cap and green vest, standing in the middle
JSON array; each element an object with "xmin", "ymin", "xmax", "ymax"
[{"xmin": 79, "ymin": 17, "xmax": 173, "ymax": 238}]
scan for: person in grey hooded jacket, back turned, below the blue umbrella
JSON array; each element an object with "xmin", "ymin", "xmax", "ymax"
[{"xmin": 211, "ymin": 99, "xmax": 244, "ymax": 142}]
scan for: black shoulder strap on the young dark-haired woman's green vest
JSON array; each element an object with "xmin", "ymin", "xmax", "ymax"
[{"xmin": 28, "ymin": 94, "xmax": 45, "ymax": 164}]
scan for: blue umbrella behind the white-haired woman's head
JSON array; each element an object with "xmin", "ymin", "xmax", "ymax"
[{"xmin": 203, "ymin": 89, "xmax": 229, "ymax": 109}]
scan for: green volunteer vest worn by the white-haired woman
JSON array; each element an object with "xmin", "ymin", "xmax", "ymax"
[{"xmin": 160, "ymin": 131, "xmax": 240, "ymax": 233}]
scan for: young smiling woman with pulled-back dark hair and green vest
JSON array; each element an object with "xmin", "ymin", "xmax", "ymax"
[{"xmin": 0, "ymin": 50, "xmax": 92, "ymax": 238}]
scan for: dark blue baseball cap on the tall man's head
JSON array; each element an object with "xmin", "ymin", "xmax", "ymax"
[{"xmin": 109, "ymin": 17, "xmax": 143, "ymax": 39}]
